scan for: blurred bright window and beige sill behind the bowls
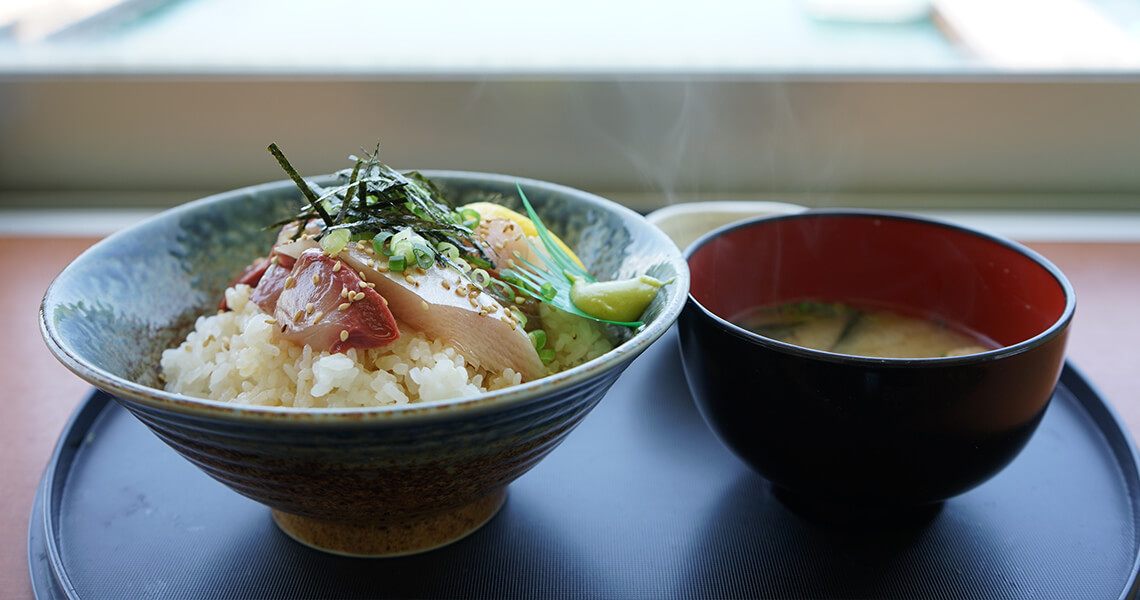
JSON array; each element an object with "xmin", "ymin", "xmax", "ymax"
[{"xmin": 0, "ymin": 0, "xmax": 1140, "ymax": 232}]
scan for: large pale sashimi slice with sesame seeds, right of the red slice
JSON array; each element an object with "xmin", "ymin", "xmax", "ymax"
[{"xmin": 337, "ymin": 244, "xmax": 546, "ymax": 381}]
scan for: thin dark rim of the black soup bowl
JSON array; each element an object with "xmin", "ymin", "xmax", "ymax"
[{"xmin": 683, "ymin": 209, "xmax": 1076, "ymax": 368}]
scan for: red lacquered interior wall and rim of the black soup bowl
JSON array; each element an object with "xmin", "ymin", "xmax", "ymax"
[{"xmin": 685, "ymin": 210, "xmax": 1075, "ymax": 362}]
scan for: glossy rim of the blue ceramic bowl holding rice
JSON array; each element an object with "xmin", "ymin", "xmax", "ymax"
[{"xmin": 40, "ymin": 170, "xmax": 690, "ymax": 427}]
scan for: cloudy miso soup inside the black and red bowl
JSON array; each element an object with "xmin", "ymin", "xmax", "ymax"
[{"xmin": 733, "ymin": 302, "xmax": 999, "ymax": 358}]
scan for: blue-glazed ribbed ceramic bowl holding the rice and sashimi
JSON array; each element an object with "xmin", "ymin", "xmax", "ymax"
[{"xmin": 40, "ymin": 171, "xmax": 689, "ymax": 556}]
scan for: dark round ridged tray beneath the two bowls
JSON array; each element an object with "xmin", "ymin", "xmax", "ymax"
[{"xmin": 29, "ymin": 331, "xmax": 1140, "ymax": 599}]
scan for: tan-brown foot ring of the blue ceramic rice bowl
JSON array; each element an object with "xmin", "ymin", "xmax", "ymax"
[{"xmin": 270, "ymin": 486, "xmax": 507, "ymax": 557}]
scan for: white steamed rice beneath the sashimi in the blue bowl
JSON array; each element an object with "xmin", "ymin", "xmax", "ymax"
[{"xmin": 162, "ymin": 285, "xmax": 612, "ymax": 408}]
